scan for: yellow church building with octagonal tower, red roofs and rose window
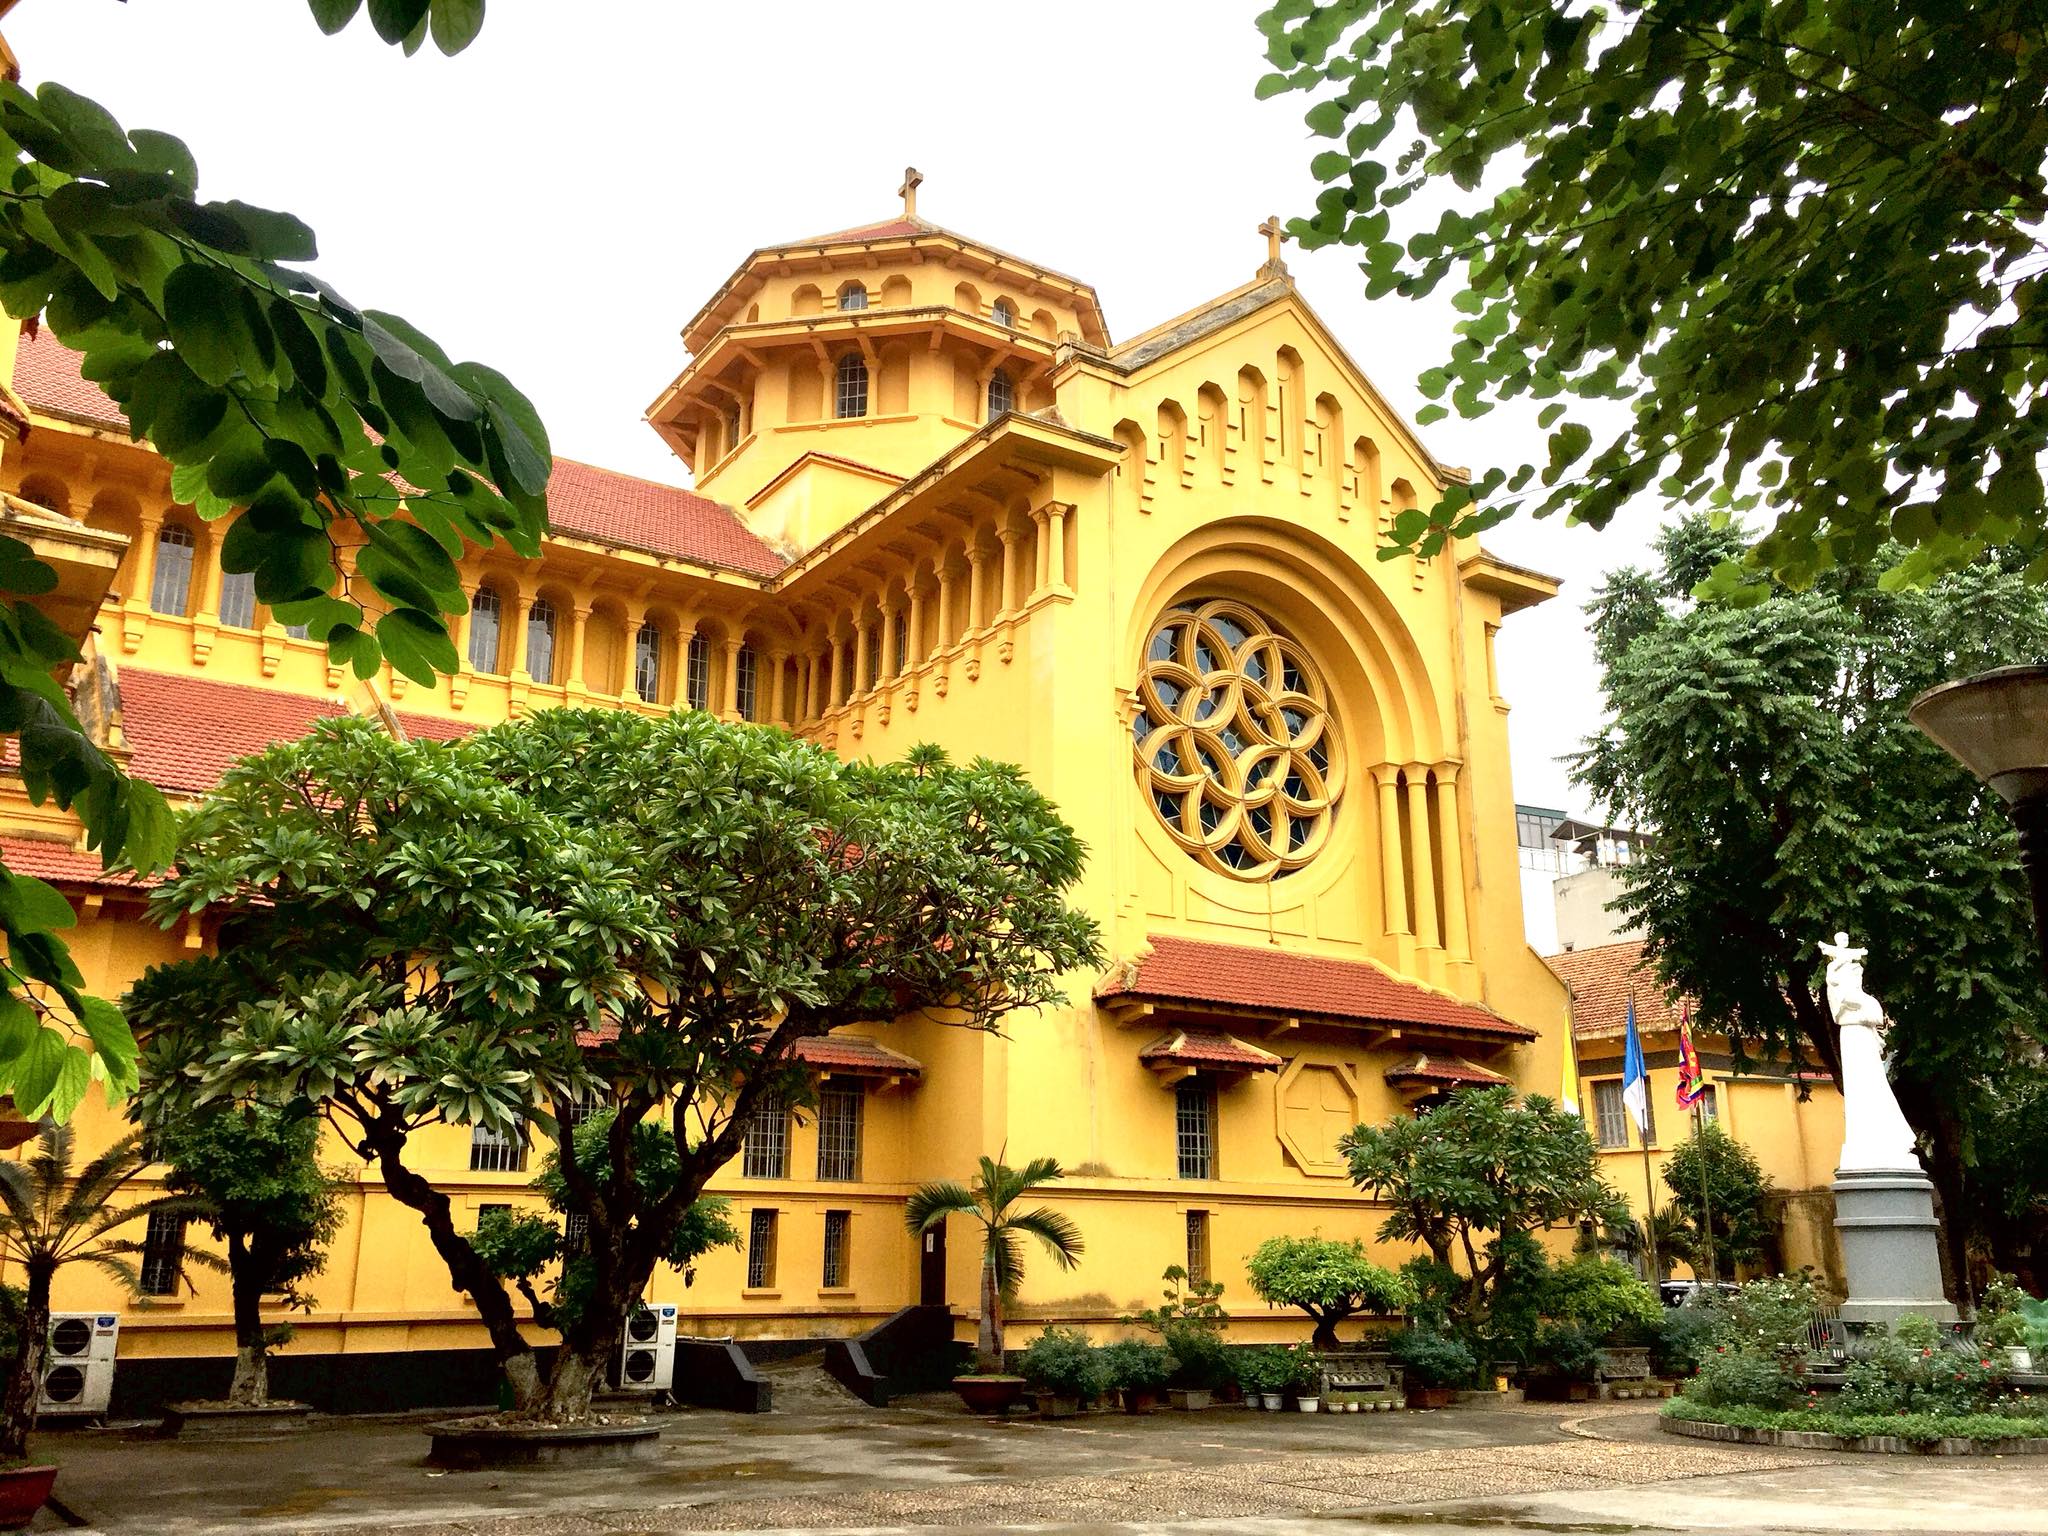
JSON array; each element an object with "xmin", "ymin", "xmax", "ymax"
[{"xmin": 0, "ymin": 174, "xmax": 1567, "ymax": 1409}]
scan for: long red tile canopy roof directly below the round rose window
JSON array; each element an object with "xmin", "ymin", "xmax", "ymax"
[{"xmin": 1096, "ymin": 938, "xmax": 1536, "ymax": 1040}]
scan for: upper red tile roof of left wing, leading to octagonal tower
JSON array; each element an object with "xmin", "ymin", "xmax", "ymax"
[{"xmin": 14, "ymin": 330, "xmax": 786, "ymax": 575}]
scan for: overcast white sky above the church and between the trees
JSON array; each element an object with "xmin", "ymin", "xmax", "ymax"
[{"xmin": 6, "ymin": 0, "xmax": 1653, "ymax": 809}]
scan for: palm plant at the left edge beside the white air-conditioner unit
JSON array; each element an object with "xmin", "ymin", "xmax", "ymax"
[{"xmin": 0, "ymin": 1124, "xmax": 219, "ymax": 1462}]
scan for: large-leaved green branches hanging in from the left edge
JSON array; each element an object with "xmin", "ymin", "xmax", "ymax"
[{"xmin": 0, "ymin": 0, "xmax": 553, "ymax": 1120}]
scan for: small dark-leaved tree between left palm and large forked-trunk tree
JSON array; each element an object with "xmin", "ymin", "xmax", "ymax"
[{"xmin": 145, "ymin": 1097, "xmax": 342, "ymax": 1405}]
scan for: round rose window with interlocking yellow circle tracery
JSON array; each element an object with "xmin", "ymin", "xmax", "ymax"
[{"xmin": 1130, "ymin": 600, "xmax": 1343, "ymax": 881}]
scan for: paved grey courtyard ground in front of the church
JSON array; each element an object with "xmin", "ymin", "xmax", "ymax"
[{"xmin": 37, "ymin": 1399, "xmax": 2048, "ymax": 1536}]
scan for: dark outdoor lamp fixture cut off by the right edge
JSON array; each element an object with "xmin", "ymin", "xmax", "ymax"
[{"xmin": 1907, "ymin": 666, "xmax": 2048, "ymax": 975}]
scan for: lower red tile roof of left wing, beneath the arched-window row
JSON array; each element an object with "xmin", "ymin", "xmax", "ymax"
[{"xmin": 121, "ymin": 668, "xmax": 471, "ymax": 795}]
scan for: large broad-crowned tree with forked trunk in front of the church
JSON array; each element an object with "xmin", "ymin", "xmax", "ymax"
[{"xmin": 131, "ymin": 709, "xmax": 1100, "ymax": 1419}]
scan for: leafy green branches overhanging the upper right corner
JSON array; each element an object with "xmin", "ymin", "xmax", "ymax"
[{"xmin": 1260, "ymin": 0, "xmax": 2048, "ymax": 586}]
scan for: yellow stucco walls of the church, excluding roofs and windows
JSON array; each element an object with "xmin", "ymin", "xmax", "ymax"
[{"xmin": 0, "ymin": 217, "xmax": 1597, "ymax": 1356}]
